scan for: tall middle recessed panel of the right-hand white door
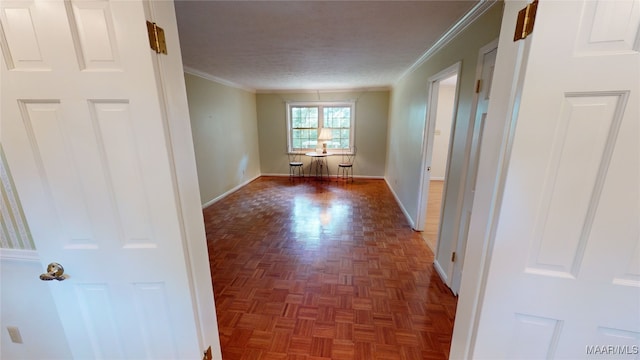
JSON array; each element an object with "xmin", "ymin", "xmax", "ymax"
[{"xmin": 520, "ymin": 93, "xmax": 626, "ymax": 278}]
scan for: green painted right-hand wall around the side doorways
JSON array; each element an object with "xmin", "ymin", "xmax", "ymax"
[{"xmin": 385, "ymin": 2, "xmax": 503, "ymax": 261}]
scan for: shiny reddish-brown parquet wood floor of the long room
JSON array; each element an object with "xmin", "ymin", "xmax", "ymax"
[{"xmin": 204, "ymin": 177, "xmax": 456, "ymax": 360}]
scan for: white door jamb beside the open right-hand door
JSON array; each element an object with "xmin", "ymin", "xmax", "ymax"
[{"xmin": 449, "ymin": 0, "xmax": 530, "ymax": 359}]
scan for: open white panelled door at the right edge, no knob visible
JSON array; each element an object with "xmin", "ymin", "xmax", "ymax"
[{"xmin": 471, "ymin": 0, "xmax": 640, "ymax": 359}]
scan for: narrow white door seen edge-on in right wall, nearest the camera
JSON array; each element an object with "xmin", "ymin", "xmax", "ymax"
[{"xmin": 451, "ymin": 43, "xmax": 498, "ymax": 294}]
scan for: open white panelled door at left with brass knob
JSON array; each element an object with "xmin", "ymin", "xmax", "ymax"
[{"xmin": 0, "ymin": 0, "xmax": 202, "ymax": 359}]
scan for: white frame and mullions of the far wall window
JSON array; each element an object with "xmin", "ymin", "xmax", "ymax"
[{"xmin": 286, "ymin": 100, "xmax": 356, "ymax": 154}]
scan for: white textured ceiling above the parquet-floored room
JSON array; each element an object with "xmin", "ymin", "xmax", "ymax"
[{"xmin": 175, "ymin": 0, "xmax": 478, "ymax": 91}]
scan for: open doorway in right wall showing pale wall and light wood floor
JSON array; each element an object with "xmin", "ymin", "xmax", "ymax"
[{"xmin": 422, "ymin": 72, "xmax": 458, "ymax": 254}]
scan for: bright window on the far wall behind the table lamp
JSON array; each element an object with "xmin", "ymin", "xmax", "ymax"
[{"xmin": 287, "ymin": 101, "xmax": 355, "ymax": 152}]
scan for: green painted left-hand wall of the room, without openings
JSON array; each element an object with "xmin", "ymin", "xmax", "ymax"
[{"xmin": 185, "ymin": 74, "xmax": 260, "ymax": 204}]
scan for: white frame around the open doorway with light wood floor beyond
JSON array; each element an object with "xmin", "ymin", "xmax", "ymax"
[{"xmin": 414, "ymin": 61, "xmax": 462, "ymax": 232}]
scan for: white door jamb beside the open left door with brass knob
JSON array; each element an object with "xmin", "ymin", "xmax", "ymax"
[{"xmin": 144, "ymin": 1, "xmax": 222, "ymax": 358}]
